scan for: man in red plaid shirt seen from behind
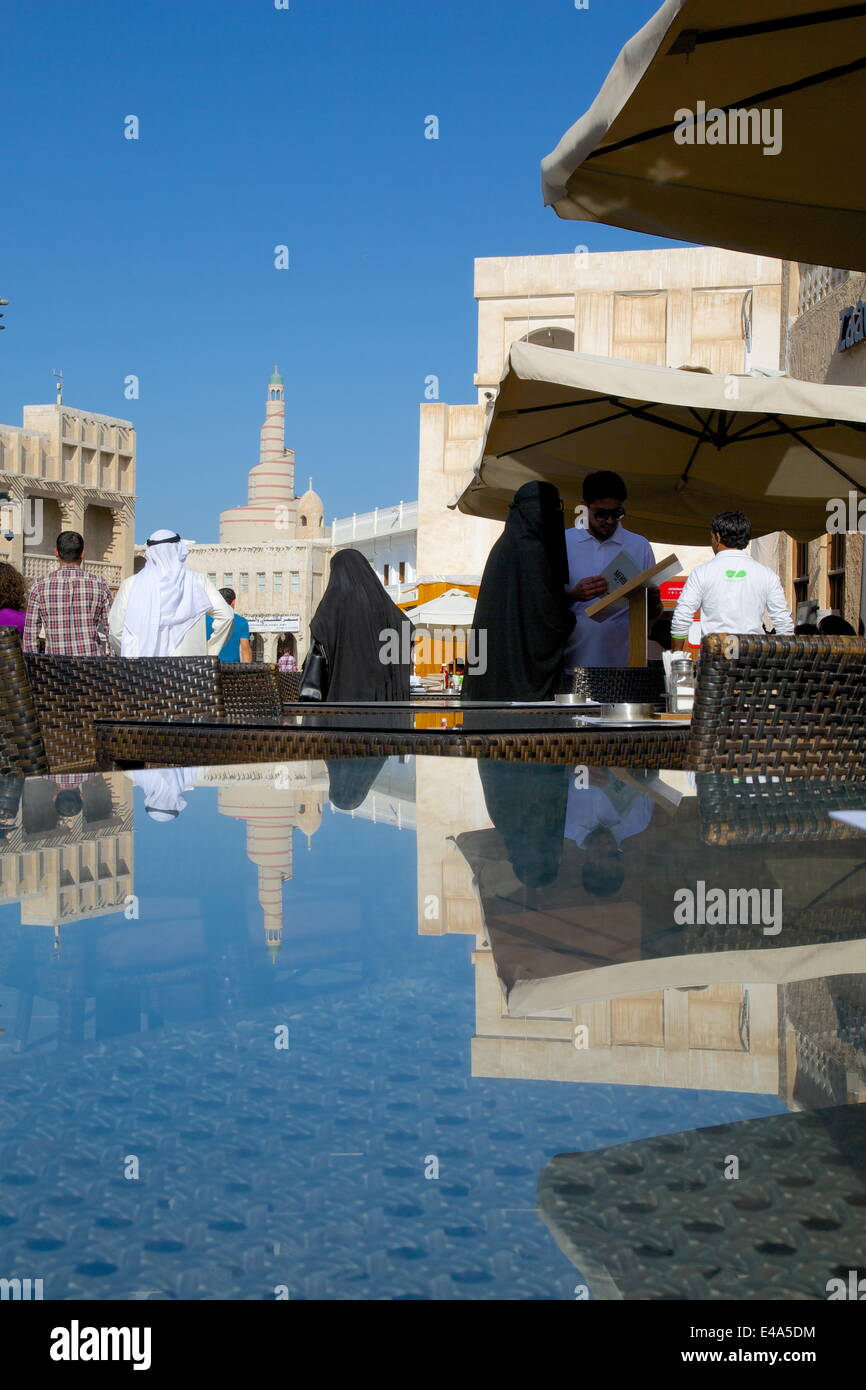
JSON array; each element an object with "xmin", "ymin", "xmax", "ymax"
[{"xmin": 24, "ymin": 531, "xmax": 111, "ymax": 656}]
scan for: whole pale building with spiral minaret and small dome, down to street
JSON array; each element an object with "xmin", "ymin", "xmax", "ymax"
[{"xmin": 180, "ymin": 368, "xmax": 331, "ymax": 662}]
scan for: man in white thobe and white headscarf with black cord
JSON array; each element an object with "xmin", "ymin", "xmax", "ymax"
[{"xmin": 108, "ymin": 531, "xmax": 235, "ymax": 657}]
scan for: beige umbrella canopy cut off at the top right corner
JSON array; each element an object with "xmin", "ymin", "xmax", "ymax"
[{"xmin": 542, "ymin": 0, "xmax": 866, "ymax": 270}]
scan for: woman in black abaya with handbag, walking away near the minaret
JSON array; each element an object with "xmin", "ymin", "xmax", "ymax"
[{"xmin": 304, "ymin": 550, "xmax": 413, "ymax": 702}]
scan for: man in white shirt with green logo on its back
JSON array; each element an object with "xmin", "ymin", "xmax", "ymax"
[{"xmin": 670, "ymin": 512, "xmax": 794, "ymax": 652}]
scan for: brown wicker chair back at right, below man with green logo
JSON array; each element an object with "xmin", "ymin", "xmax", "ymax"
[{"xmin": 687, "ymin": 632, "xmax": 866, "ymax": 781}]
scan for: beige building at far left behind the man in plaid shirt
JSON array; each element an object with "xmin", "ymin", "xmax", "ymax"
[{"xmin": 0, "ymin": 403, "xmax": 135, "ymax": 589}]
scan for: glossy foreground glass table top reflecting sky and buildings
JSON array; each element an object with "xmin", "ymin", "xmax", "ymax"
[{"xmin": 0, "ymin": 758, "xmax": 866, "ymax": 1300}]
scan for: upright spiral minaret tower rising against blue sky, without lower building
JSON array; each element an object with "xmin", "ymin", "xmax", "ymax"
[{"xmin": 220, "ymin": 367, "xmax": 297, "ymax": 543}]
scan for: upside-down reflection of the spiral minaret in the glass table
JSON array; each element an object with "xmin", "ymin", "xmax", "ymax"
[{"xmin": 197, "ymin": 763, "xmax": 328, "ymax": 965}]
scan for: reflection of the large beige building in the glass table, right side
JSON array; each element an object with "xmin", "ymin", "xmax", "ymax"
[{"xmin": 416, "ymin": 758, "xmax": 866, "ymax": 1109}]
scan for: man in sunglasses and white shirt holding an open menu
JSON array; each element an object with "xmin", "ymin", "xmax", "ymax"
[{"xmin": 566, "ymin": 470, "xmax": 655, "ymax": 671}]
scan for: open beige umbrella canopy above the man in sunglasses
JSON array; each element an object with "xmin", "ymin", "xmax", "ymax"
[{"xmin": 457, "ymin": 343, "xmax": 866, "ymax": 545}]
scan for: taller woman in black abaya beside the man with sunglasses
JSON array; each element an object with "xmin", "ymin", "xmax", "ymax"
[{"xmin": 463, "ymin": 482, "xmax": 574, "ymax": 701}]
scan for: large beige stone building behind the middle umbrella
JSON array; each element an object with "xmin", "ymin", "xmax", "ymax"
[{"xmin": 417, "ymin": 246, "xmax": 784, "ymax": 600}]
